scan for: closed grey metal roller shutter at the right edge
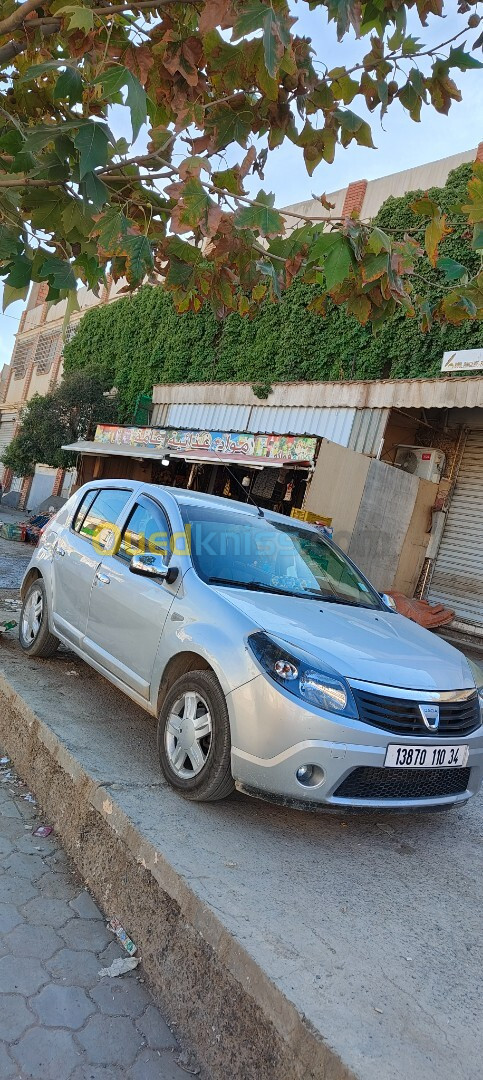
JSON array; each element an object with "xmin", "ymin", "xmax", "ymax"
[{"xmin": 428, "ymin": 430, "xmax": 483, "ymax": 626}]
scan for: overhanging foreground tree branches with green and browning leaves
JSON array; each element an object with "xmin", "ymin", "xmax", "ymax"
[{"xmin": 0, "ymin": 0, "xmax": 483, "ymax": 328}]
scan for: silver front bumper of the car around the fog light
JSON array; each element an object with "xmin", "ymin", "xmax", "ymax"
[{"xmin": 228, "ymin": 675, "xmax": 483, "ymax": 810}]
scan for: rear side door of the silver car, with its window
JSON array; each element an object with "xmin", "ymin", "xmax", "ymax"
[{"xmin": 52, "ymin": 487, "xmax": 133, "ymax": 647}]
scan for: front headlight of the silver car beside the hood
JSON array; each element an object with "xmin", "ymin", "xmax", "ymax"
[{"xmin": 249, "ymin": 632, "xmax": 358, "ymax": 719}]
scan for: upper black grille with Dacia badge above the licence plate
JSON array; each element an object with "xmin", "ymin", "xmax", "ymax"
[{"xmin": 352, "ymin": 689, "xmax": 481, "ymax": 739}]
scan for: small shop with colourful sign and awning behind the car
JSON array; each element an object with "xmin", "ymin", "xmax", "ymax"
[{"xmin": 63, "ymin": 424, "xmax": 320, "ymax": 514}]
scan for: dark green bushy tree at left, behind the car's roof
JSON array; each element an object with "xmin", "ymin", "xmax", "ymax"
[{"xmin": 2, "ymin": 372, "xmax": 118, "ymax": 476}]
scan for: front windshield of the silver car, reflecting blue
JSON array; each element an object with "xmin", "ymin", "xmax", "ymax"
[{"xmin": 182, "ymin": 507, "xmax": 383, "ymax": 608}]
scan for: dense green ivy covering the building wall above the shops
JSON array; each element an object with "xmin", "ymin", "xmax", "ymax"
[{"xmin": 65, "ymin": 164, "xmax": 483, "ymax": 422}]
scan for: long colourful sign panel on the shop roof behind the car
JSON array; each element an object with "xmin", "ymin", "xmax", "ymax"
[{"xmin": 95, "ymin": 423, "xmax": 317, "ymax": 461}]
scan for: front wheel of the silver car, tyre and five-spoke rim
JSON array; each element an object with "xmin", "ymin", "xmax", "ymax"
[{"xmin": 158, "ymin": 671, "xmax": 234, "ymax": 802}]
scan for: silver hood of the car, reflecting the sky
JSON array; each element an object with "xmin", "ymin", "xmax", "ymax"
[{"xmin": 223, "ymin": 589, "xmax": 474, "ymax": 690}]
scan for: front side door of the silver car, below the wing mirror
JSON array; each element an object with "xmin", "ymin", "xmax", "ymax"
[{"xmin": 84, "ymin": 495, "xmax": 179, "ymax": 699}]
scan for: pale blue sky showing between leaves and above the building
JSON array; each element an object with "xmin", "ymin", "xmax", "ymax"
[{"xmin": 0, "ymin": 0, "xmax": 483, "ymax": 367}]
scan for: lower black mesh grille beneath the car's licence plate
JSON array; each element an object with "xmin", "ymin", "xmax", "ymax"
[{"xmin": 334, "ymin": 766, "xmax": 471, "ymax": 799}]
